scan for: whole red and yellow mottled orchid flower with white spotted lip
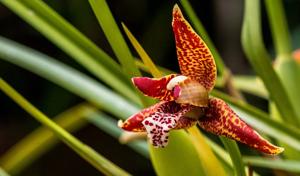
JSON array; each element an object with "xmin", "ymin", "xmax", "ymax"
[{"xmin": 118, "ymin": 5, "xmax": 284, "ymax": 154}]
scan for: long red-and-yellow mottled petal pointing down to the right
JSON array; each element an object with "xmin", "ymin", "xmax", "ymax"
[{"xmin": 199, "ymin": 98, "xmax": 283, "ymax": 154}]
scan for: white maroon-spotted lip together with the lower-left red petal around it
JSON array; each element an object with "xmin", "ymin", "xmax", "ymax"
[{"xmin": 119, "ymin": 101, "xmax": 195, "ymax": 147}]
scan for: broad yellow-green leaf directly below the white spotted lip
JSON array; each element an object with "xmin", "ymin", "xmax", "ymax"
[{"xmin": 150, "ymin": 130, "xmax": 205, "ymax": 176}]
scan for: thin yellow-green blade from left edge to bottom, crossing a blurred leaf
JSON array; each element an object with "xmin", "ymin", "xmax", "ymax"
[{"xmin": 0, "ymin": 78, "xmax": 129, "ymax": 176}]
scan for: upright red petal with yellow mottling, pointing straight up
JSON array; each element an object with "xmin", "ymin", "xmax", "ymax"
[{"xmin": 172, "ymin": 5, "xmax": 217, "ymax": 91}]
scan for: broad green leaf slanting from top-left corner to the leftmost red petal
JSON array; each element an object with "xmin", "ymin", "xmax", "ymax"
[{"xmin": 0, "ymin": 0, "xmax": 139, "ymax": 102}]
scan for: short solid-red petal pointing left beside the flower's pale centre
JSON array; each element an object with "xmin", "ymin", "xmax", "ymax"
[{"xmin": 132, "ymin": 74, "xmax": 178, "ymax": 101}]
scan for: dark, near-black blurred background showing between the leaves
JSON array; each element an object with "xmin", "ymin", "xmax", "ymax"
[{"xmin": 0, "ymin": 0, "xmax": 300, "ymax": 176}]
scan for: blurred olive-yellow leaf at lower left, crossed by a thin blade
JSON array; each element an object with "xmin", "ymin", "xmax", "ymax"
[{"xmin": 0, "ymin": 104, "xmax": 96, "ymax": 175}]
